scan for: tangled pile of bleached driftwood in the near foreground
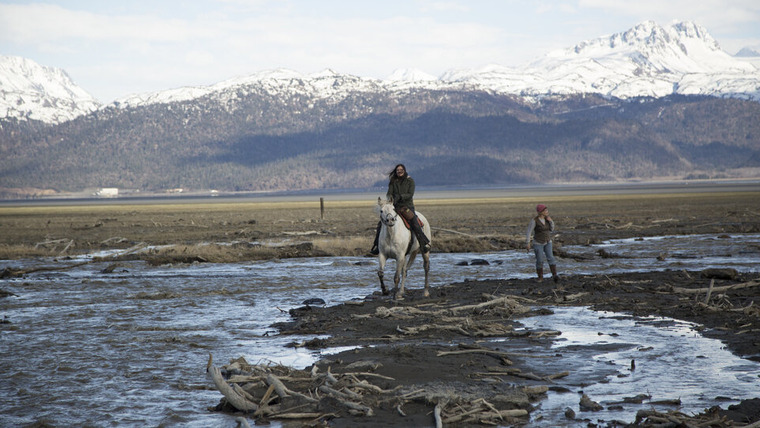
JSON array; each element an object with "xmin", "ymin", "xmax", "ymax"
[{"xmin": 206, "ymin": 356, "xmax": 536, "ymax": 426}]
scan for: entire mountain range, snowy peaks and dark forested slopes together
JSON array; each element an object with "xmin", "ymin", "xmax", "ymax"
[{"xmin": 0, "ymin": 22, "xmax": 760, "ymax": 194}]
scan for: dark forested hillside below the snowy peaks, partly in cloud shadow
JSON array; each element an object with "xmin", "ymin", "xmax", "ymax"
[{"xmin": 0, "ymin": 89, "xmax": 760, "ymax": 196}]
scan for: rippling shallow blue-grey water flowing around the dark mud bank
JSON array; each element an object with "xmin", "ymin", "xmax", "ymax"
[{"xmin": 0, "ymin": 235, "xmax": 760, "ymax": 427}]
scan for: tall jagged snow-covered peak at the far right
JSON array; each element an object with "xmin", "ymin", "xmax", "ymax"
[{"xmin": 441, "ymin": 21, "xmax": 760, "ymax": 100}]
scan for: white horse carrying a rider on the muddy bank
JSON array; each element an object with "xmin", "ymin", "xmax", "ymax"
[{"xmin": 375, "ymin": 198, "xmax": 431, "ymax": 299}]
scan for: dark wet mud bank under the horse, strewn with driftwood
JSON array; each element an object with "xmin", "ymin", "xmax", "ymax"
[{"xmin": 233, "ymin": 270, "xmax": 760, "ymax": 427}]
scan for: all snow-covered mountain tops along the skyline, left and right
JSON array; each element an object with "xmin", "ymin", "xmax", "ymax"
[{"xmin": 0, "ymin": 21, "xmax": 760, "ymax": 123}]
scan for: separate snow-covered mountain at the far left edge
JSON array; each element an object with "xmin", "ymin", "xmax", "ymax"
[{"xmin": 0, "ymin": 56, "xmax": 100, "ymax": 123}]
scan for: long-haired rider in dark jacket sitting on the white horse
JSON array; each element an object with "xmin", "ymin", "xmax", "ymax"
[{"xmin": 369, "ymin": 163, "xmax": 430, "ymax": 254}]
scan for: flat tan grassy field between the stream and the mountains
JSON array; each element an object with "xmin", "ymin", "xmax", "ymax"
[{"xmin": 0, "ymin": 191, "xmax": 760, "ymax": 263}]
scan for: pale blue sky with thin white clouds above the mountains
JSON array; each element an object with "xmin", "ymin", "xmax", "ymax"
[{"xmin": 0, "ymin": 0, "xmax": 760, "ymax": 103}]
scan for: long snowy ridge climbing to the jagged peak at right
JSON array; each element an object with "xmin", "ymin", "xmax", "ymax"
[{"xmin": 115, "ymin": 21, "xmax": 760, "ymax": 112}]
